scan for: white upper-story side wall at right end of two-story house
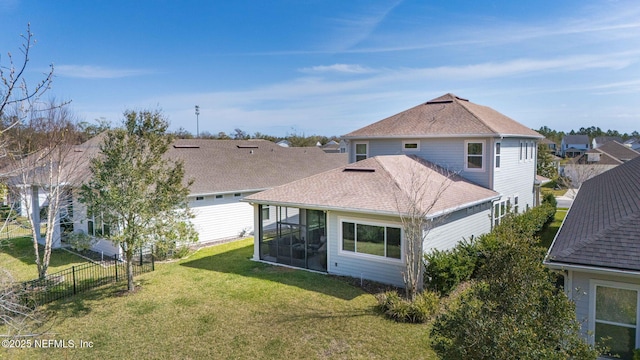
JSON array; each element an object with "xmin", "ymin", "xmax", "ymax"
[{"xmin": 491, "ymin": 138, "xmax": 538, "ymax": 212}]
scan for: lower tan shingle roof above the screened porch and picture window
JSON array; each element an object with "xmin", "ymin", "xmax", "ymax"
[{"xmin": 243, "ymin": 155, "xmax": 500, "ymax": 217}]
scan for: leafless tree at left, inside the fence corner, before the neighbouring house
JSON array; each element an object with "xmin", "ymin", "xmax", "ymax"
[{"xmin": 9, "ymin": 101, "xmax": 88, "ymax": 278}]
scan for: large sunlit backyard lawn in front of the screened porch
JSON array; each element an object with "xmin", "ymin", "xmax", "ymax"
[{"xmin": 0, "ymin": 239, "xmax": 436, "ymax": 359}]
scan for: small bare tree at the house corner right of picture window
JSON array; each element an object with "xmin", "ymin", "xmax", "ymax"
[{"xmin": 393, "ymin": 156, "xmax": 456, "ymax": 300}]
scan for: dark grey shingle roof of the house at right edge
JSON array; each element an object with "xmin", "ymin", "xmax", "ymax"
[{"xmin": 545, "ymin": 157, "xmax": 640, "ymax": 271}]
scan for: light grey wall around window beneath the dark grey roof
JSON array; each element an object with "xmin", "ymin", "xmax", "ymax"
[{"xmin": 565, "ymin": 271, "xmax": 640, "ymax": 344}]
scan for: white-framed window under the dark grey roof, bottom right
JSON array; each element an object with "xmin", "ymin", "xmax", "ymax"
[{"xmin": 591, "ymin": 283, "xmax": 638, "ymax": 359}]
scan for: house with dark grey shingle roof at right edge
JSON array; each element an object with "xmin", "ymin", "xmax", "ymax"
[{"xmin": 544, "ymin": 157, "xmax": 640, "ymax": 359}]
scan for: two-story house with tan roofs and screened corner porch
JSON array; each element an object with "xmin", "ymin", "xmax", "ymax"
[{"xmin": 243, "ymin": 94, "xmax": 542, "ymax": 286}]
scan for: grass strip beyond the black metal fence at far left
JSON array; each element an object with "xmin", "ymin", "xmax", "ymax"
[{"xmin": 0, "ymin": 237, "xmax": 87, "ymax": 281}]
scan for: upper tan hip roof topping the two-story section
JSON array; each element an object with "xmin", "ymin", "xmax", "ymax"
[{"xmin": 344, "ymin": 94, "xmax": 543, "ymax": 139}]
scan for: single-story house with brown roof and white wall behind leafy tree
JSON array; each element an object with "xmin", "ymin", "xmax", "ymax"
[{"xmin": 6, "ymin": 137, "xmax": 347, "ymax": 255}]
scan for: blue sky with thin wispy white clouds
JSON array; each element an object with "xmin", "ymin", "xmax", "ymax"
[{"xmin": 0, "ymin": 0, "xmax": 640, "ymax": 136}]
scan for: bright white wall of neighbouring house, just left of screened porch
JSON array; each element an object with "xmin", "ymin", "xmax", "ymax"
[{"xmin": 189, "ymin": 193, "xmax": 254, "ymax": 242}]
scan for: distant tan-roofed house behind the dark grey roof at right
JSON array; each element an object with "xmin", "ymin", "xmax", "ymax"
[{"xmin": 561, "ymin": 141, "xmax": 640, "ymax": 189}]
